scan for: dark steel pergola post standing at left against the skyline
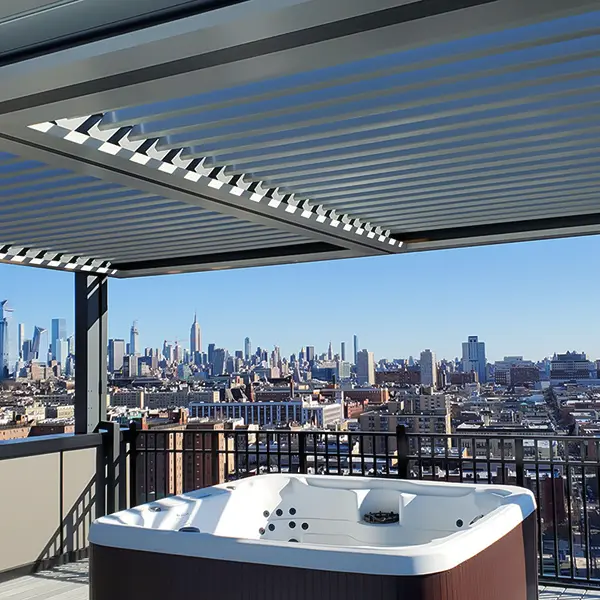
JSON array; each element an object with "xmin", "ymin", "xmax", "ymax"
[{"xmin": 75, "ymin": 273, "xmax": 108, "ymax": 433}]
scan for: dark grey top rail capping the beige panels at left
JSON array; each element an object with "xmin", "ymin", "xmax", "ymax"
[{"xmin": 0, "ymin": 433, "xmax": 102, "ymax": 460}]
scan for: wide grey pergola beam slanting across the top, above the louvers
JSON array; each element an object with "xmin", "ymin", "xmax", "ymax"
[{"xmin": 0, "ymin": 0, "xmax": 597, "ymax": 124}]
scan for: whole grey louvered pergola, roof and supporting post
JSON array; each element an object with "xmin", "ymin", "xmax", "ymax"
[{"xmin": 0, "ymin": 0, "xmax": 600, "ymax": 433}]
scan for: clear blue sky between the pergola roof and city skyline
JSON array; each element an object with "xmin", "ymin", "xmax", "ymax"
[{"xmin": 0, "ymin": 236, "xmax": 600, "ymax": 360}]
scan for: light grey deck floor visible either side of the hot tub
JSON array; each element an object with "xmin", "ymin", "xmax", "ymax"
[{"xmin": 0, "ymin": 561, "xmax": 600, "ymax": 600}]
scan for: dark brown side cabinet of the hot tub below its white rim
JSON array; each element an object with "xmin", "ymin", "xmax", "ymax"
[{"xmin": 90, "ymin": 513, "xmax": 538, "ymax": 600}]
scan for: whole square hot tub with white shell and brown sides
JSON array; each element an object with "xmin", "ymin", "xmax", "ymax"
[{"xmin": 89, "ymin": 474, "xmax": 537, "ymax": 600}]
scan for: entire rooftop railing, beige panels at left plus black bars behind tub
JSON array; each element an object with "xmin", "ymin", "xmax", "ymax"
[{"xmin": 0, "ymin": 423, "xmax": 600, "ymax": 588}]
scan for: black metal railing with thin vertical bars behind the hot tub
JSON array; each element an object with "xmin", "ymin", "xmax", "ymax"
[{"xmin": 127, "ymin": 426, "xmax": 600, "ymax": 587}]
